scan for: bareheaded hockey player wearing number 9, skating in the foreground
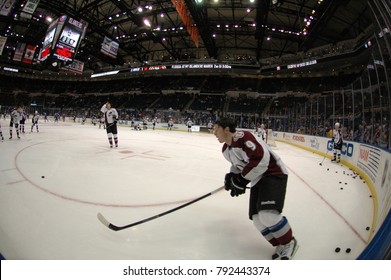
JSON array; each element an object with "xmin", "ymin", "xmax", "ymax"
[{"xmin": 214, "ymin": 118, "xmax": 298, "ymax": 260}]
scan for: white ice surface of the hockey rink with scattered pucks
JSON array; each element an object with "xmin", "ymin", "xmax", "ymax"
[{"xmin": 0, "ymin": 120, "xmax": 373, "ymax": 260}]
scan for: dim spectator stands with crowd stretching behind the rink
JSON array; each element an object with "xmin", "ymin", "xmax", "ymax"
[{"xmin": 0, "ymin": 76, "xmax": 390, "ymax": 151}]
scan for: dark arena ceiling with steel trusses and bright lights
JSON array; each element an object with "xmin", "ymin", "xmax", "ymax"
[{"xmin": 0, "ymin": 0, "xmax": 372, "ymax": 70}]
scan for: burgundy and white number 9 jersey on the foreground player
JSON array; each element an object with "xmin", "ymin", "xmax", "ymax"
[{"xmin": 223, "ymin": 131, "xmax": 288, "ymax": 185}]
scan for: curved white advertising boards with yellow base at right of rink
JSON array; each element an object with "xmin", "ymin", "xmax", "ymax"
[{"xmin": 273, "ymin": 132, "xmax": 391, "ymax": 259}]
